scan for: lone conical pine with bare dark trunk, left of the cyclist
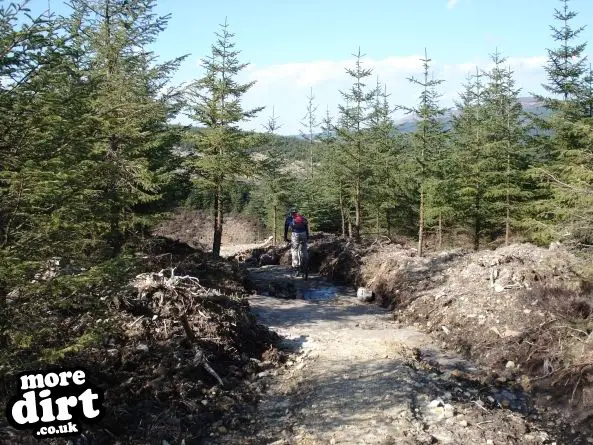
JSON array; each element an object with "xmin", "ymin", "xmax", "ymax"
[{"xmin": 187, "ymin": 20, "xmax": 263, "ymax": 256}]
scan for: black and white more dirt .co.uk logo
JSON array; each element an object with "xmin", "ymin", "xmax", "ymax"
[{"xmin": 6, "ymin": 368, "xmax": 105, "ymax": 439}]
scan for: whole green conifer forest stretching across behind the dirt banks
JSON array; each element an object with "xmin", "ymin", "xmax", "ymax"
[{"xmin": 0, "ymin": 0, "xmax": 593, "ymax": 402}]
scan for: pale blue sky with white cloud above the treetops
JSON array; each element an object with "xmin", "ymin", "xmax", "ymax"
[{"xmin": 29, "ymin": 0, "xmax": 593, "ymax": 135}]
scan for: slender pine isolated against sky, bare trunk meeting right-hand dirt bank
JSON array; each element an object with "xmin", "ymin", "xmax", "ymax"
[{"xmin": 404, "ymin": 49, "xmax": 446, "ymax": 256}]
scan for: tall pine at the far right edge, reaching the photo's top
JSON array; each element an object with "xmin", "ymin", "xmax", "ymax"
[{"xmin": 534, "ymin": 0, "xmax": 593, "ymax": 244}]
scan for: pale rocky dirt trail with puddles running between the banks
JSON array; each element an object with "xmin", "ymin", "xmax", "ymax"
[{"xmin": 219, "ymin": 266, "xmax": 564, "ymax": 445}]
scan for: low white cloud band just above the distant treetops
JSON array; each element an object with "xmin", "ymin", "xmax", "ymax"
[{"xmin": 229, "ymin": 54, "xmax": 546, "ymax": 134}]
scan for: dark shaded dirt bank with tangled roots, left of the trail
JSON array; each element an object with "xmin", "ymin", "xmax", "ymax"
[{"xmin": 0, "ymin": 238, "xmax": 278, "ymax": 445}]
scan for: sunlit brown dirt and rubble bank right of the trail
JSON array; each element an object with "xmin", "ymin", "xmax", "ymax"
[{"xmin": 311, "ymin": 238, "xmax": 593, "ymax": 431}]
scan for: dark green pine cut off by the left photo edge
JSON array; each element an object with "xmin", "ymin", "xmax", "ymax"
[{"xmin": 0, "ymin": 2, "xmax": 63, "ymax": 270}]
